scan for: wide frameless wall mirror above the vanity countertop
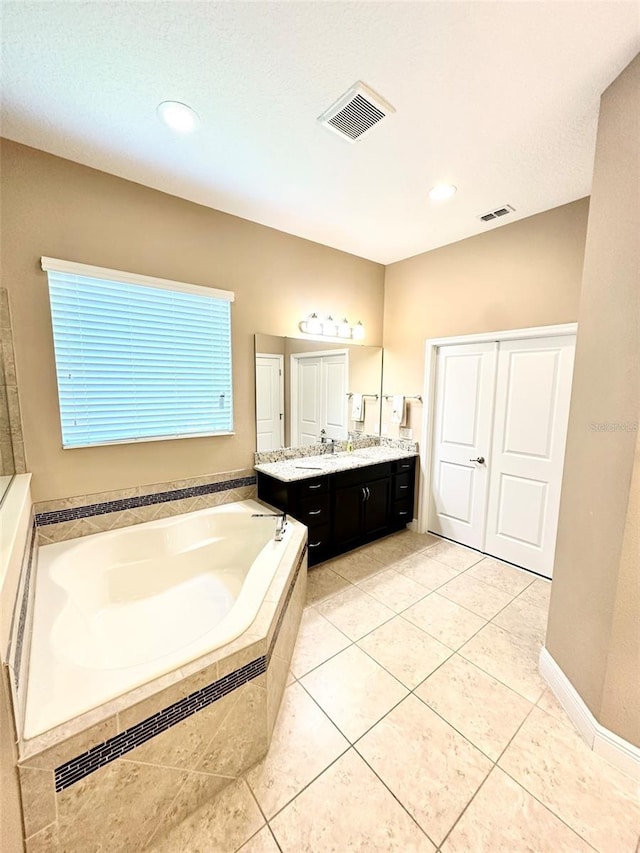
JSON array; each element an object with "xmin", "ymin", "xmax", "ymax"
[{"xmin": 255, "ymin": 335, "xmax": 382, "ymax": 450}]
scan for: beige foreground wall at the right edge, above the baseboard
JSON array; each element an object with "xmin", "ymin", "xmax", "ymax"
[{"xmin": 547, "ymin": 57, "xmax": 640, "ymax": 746}]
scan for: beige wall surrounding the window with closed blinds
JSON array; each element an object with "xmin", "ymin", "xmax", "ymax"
[{"xmin": 0, "ymin": 140, "xmax": 384, "ymax": 500}]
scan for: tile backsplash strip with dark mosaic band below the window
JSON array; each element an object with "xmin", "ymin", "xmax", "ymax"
[{"xmin": 34, "ymin": 468, "xmax": 256, "ymax": 545}]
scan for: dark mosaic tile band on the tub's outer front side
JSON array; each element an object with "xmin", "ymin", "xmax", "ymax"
[{"xmin": 55, "ymin": 545, "xmax": 307, "ymax": 792}]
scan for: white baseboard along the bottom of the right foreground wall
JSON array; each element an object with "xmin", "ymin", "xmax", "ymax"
[{"xmin": 539, "ymin": 646, "xmax": 640, "ymax": 779}]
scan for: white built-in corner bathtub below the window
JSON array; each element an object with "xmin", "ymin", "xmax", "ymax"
[{"xmin": 24, "ymin": 501, "xmax": 295, "ymax": 739}]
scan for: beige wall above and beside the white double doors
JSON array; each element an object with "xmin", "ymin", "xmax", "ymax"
[{"xmin": 383, "ymin": 199, "xmax": 588, "ymax": 439}]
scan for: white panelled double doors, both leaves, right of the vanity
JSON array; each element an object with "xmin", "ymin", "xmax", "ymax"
[{"xmin": 430, "ymin": 336, "xmax": 575, "ymax": 577}]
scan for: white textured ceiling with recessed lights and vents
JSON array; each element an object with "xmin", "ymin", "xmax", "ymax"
[{"xmin": 1, "ymin": 0, "xmax": 640, "ymax": 263}]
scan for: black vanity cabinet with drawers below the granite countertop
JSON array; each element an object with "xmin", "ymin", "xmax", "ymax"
[{"xmin": 258, "ymin": 457, "xmax": 416, "ymax": 566}]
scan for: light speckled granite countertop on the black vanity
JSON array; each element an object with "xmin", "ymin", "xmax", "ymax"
[{"xmin": 255, "ymin": 447, "xmax": 418, "ymax": 483}]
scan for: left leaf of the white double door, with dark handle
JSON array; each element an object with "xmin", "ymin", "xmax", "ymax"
[{"xmin": 429, "ymin": 342, "xmax": 498, "ymax": 550}]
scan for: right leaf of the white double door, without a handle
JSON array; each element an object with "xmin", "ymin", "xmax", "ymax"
[{"xmin": 484, "ymin": 336, "xmax": 575, "ymax": 577}]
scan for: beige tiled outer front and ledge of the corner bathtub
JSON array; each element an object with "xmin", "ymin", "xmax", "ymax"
[{"xmin": 19, "ymin": 532, "xmax": 306, "ymax": 853}]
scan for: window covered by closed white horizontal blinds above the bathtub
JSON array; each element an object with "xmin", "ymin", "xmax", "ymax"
[{"xmin": 42, "ymin": 258, "xmax": 233, "ymax": 448}]
